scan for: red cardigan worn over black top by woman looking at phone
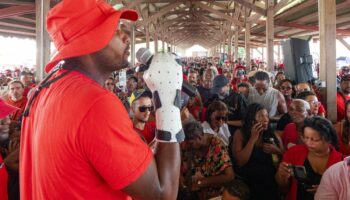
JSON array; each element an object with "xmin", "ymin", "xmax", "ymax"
[{"xmin": 282, "ymin": 144, "xmax": 342, "ymax": 200}]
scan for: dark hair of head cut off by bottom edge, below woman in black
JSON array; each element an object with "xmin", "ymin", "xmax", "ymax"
[{"xmin": 224, "ymin": 179, "xmax": 250, "ymax": 200}]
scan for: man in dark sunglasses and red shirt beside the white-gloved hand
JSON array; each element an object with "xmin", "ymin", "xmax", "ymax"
[{"xmin": 130, "ymin": 89, "xmax": 156, "ymax": 144}]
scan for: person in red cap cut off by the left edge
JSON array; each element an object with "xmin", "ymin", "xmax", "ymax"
[{"xmin": 0, "ymin": 99, "xmax": 18, "ymax": 200}]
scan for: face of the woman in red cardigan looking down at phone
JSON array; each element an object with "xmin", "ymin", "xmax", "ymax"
[{"xmin": 303, "ymin": 127, "xmax": 329, "ymax": 154}]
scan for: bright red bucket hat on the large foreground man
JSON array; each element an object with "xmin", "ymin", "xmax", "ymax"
[{"xmin": 45, "ymin": 0, "xmax": 138, "ymax": 72}]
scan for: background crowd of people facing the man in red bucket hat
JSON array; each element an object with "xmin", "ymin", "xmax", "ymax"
[{"xmin": 0, "ymin": 57, "xmax": 350, "ymax": 200}]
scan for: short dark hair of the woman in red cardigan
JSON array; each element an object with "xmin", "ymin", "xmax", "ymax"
[{"xmin": 303, "ymin": 116, "xmax": 339, "ymax": 150}]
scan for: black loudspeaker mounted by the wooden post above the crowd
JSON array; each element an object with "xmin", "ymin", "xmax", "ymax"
[{"xmin": 282, "ymin": 38, "xmax": 313, "ymax": 83}]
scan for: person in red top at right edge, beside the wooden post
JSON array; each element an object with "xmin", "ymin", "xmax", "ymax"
[{"xmin": 337, "ymin": 75, "xmax": 350, "ymax": 121}]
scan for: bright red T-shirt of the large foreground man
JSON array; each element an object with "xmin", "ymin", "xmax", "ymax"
[{"xmin": 20, "ymin": 70, "xmax": 153, "ymax": 200}]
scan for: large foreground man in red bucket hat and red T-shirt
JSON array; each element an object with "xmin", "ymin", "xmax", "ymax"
[{"xmin": 20, "ymin": 0, "xmax": 180, "ymax": 200}]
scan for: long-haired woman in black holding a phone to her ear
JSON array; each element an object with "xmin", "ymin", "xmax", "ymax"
[{"xmin": 232, "ymin": 103, "xmax": 282, "ymax": 200}]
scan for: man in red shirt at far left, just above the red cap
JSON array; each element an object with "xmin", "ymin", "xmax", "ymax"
[{"xmin": 6, "ymin": 81, "xmax": 28, "ymax": 122}]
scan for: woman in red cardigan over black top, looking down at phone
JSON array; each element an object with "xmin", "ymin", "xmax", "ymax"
[{"xmin": 275, "ymin": 117, "xmax": 342, "ymax": 200}]
